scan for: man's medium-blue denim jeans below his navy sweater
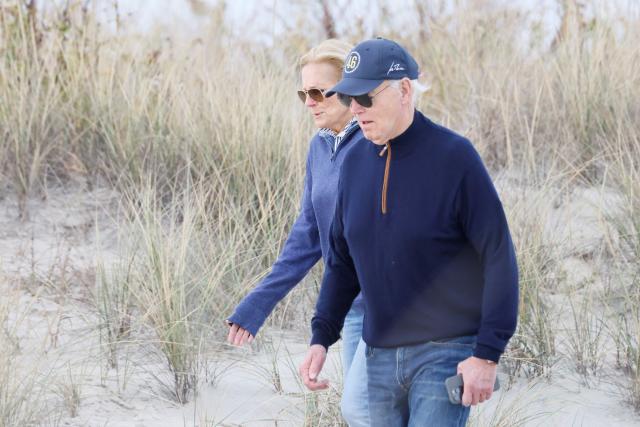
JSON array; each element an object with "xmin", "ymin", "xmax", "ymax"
[{"xmin": 365, "ymin": 336, "xmax": 476, "ymax": 427}]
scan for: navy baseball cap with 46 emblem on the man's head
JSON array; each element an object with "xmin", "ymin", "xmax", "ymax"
[{"xmin": 325, "ymin": 37, "xmax": 419, "ymax": 96}]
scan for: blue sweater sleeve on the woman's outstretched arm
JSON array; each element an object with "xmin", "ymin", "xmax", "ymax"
[{"xmin": 228, "ymin": 151, "xmax": 322, "ymax": 337}]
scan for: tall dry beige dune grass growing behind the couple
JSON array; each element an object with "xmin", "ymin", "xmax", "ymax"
[{"xmin": 0, "ymin": 2, "xmax": 640, "ymax": 424}]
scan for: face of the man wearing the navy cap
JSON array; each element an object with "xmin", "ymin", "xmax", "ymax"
[{"xmin": 350, "ymin": 81, "xmax": 402, "ymax": 145}]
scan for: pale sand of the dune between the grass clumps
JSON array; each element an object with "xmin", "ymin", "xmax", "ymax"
[{"xmin": 0, "ymin": 182, "xmax": 640, "ymax": 427}]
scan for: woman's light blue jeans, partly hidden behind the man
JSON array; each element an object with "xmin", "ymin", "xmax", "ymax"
[{"xmin": 340, "ymin": 302, "xmax": 370, "ymax": 427}]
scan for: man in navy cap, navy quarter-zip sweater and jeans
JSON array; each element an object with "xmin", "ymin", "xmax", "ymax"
[{"xmin": 300, "ymin": 38, "xmax": 518, "ymax": 427}]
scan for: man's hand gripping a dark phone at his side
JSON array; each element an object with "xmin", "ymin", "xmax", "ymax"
[{"xmin": 458, "ymin": 356, "xmax": 498, "ymax": 406}]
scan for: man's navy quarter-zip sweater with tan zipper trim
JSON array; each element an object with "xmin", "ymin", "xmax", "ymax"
[{"xmin": 311, "ymin": 110, "xmax": 518, "ymax": 362}]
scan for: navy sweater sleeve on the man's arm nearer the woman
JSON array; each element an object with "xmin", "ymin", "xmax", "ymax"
[{"xmin": 311, "ymin": 179, "xmax": 360, "ymax": 349}]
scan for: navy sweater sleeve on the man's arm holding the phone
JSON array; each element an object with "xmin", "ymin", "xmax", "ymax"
[{"xmin": 458, "ymin": 153, "xmax": 518, "ymax": 362}]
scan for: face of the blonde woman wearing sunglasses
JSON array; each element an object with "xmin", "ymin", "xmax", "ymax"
[{"xmin": 300, "ymin": 62, "xmax": 352, "ymax": 132}]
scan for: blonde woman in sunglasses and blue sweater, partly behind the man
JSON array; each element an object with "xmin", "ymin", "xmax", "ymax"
[{"xmin": 227, "ymin": 39, "xmax": 369, "ymax": 426}]
